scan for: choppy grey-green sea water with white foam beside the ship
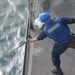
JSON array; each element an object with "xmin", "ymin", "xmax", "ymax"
[{"xmin": 0, "ymin": 0, "xmax": 29, "ymax": 75}]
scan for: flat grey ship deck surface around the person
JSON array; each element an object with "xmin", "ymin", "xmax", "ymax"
[{"xmin": 31, "ymin": 0, "xmax": 75, "ymax": 75}]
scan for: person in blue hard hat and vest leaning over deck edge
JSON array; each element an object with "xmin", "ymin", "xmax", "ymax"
[{"xmin": 27, "ymin": 12, "xmax": 75, "ymax": 75}]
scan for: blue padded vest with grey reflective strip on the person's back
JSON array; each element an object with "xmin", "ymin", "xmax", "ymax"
[{"xmin": 44, "ymin": 17, "xmax": 70, "ymax": 42}]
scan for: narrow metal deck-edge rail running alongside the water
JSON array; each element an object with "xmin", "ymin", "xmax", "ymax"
[{"xmin": 22, "ymin": 1, "xmax": 32, "ymax": 75}]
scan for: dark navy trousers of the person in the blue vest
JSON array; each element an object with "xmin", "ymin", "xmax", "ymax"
[{"xmin": 52, "ymin": 36, "xmax": 75, "ymax": 68}]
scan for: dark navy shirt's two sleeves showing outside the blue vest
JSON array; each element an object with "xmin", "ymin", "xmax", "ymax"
[{"xmin": 37, "ymin": 17, "xmax": 75, "ymax": 40}]
